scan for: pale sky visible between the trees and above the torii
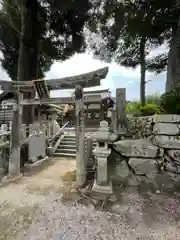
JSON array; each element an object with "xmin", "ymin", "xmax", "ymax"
[{"xmin": 0, "ymin": 53, "xmax": 166, "ymax": 100}]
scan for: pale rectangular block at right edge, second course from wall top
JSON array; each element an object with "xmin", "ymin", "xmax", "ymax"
[{"xmin": 153, "ymin": 123, "xmax": 180, "ymax": 136}]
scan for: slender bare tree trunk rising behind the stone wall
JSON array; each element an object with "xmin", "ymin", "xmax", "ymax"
[{"xmin": 140, "ymin": 37, "xmax": 146, "ymax": 106}]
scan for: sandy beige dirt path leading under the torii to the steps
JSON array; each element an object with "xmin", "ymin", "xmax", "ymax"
[{"xmin": 0, "ymin": 159, "xmax": 75, "ymax": 240}]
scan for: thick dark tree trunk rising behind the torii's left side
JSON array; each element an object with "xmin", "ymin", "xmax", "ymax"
[{"xmin": 18, "ymin": 0, "xmax": 40, "ymax": 124}]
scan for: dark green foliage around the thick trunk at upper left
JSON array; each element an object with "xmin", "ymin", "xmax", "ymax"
[{"xmin": 0, "ymin": 0, "xmax": 91, "ymax": 79}]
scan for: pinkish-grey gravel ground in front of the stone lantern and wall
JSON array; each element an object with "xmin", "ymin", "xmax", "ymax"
[{"xmin": 17, "ymin": 189, "xmax": 180, "ymax": 240}]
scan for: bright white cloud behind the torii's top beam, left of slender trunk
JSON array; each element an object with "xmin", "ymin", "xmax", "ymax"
[{"xmin": 46, "ymin": 53, "xmax": 140, "ymax": 96}]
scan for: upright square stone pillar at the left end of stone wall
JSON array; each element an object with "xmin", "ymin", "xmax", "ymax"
[{"xmin": 116, "ymin": 88, "xmax": 127, "ymax": 135}]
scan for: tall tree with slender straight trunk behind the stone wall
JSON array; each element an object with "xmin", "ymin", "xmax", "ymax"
[{"xmin": 90, "ymin": 0, "xmax": 174, "ymax": 105}]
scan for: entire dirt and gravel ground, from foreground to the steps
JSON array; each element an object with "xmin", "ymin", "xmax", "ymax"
[{"xmin": 0, "ymin": 160, "xmax": 180, "ymax": 240}]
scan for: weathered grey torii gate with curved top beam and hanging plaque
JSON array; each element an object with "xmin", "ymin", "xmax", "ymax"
[{"xmin": 0, "ymin": 68, "xmax": 108, "ymax": 186}]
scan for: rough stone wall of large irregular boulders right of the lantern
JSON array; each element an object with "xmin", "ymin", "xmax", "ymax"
[{"xmin": 108, "ymin": 115, "xmax": 180, "ymax": 192}]
